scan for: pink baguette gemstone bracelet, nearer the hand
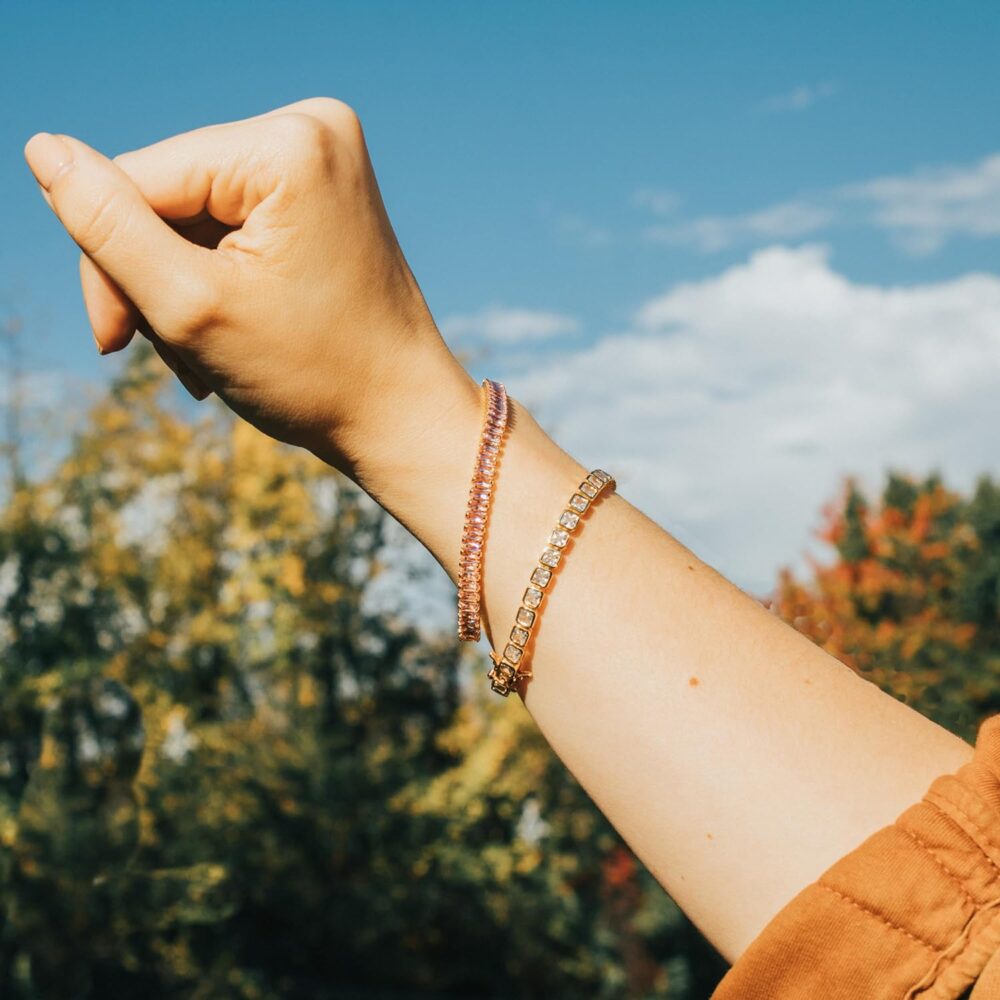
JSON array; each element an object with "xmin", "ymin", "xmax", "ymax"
[{"xmin": 458, "ymin": 378, "xmax": 509, "ymax": 642}]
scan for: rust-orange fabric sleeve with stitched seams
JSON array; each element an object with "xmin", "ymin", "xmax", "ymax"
[{"xmin": 712, "ymin": 714, "xmax": 1000, "ymax": 1000}]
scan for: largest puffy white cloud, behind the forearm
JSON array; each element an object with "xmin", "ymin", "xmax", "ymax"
[{"xmin": 505, "ymin": 246, "xmax": 1000, "ymax": 594}]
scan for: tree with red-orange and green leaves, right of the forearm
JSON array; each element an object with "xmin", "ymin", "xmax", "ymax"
[{"xmin": 774, "ymin": 473, "xmax": 1000, "ymax": 742}]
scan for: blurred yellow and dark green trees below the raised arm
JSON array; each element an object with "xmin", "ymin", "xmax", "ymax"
[{"xmin": 0, "ymin": 345, "xmax": 712, "ymax": 1000}]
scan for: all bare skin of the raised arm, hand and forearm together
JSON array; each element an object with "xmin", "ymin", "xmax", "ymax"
[{"xmin": 25, "ymin": 98, "xmax": 972, "ymax": 962}]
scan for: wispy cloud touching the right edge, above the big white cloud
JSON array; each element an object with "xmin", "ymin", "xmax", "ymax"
[{"xmin": 842, "ymin": 153, "xmax": 1000, "ymax": 255}]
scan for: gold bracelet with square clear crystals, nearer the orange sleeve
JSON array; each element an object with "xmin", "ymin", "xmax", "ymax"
[{"xmin": 488, "ymin": 469, "xmax": 615, "ymax": 698}]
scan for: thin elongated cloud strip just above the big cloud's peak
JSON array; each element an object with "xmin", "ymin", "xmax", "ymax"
[{"xmin": 645, "ymin": 201, "xmax": 833, "ymax": 253}]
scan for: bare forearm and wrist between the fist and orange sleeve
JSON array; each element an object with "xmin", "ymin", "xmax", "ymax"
[{"xmin": 340, "ymin": 342, "xmax": 972, "ymax": 961}]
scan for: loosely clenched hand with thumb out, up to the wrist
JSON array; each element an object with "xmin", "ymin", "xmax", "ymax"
[{"xmin": 25, "ymin": 98, "xmax": 471, "ymax": 473}]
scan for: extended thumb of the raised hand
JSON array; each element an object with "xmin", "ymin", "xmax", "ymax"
[{"xmin": 24, "ymin": 132, "xmax": 214, "ymax": 329}]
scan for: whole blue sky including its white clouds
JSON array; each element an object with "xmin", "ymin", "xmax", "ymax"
[{"xmin": 0, "ymin": 2, "xmax": 1000, "ymax": 591}]
